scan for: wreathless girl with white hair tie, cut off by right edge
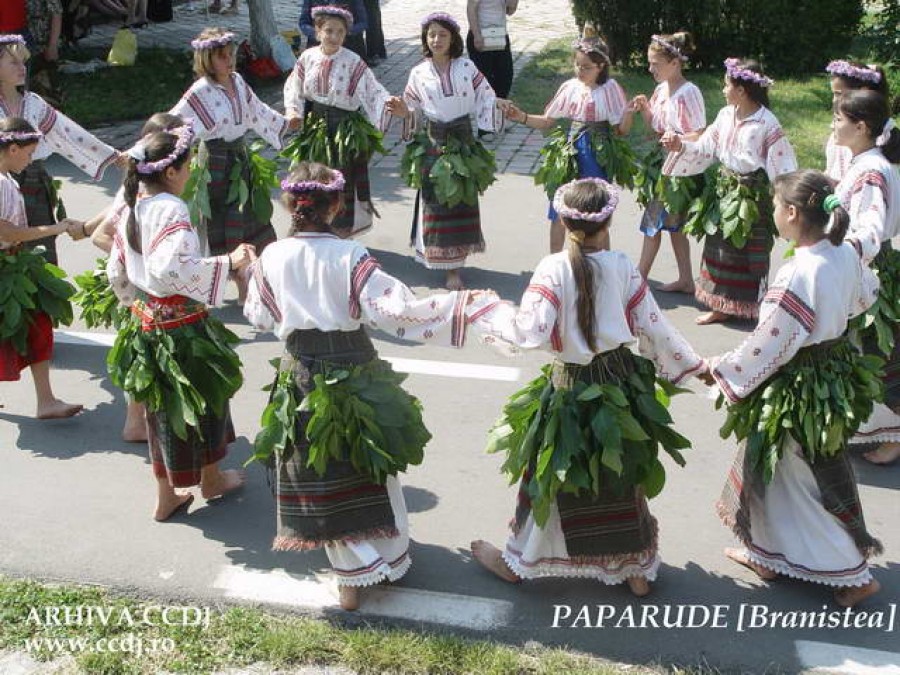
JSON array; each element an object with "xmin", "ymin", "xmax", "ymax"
[{"xmin": 832, "ymin": 89, "xmax": 900, "ymax": 464}]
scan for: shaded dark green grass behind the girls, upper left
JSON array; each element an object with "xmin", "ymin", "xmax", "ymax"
[{"xmin": 60, "ymin": 49, "xmax": 194, "ymax": 128}]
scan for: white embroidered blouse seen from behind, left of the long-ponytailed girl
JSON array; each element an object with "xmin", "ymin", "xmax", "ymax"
[{"xmin": 244, "ymin": 232, "xmax": 487, "ymax": 347}]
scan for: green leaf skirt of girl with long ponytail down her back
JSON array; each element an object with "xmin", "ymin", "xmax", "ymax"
[{"xmin": 488, "ymin": 347, "xmax": 690, "ymax": 526}]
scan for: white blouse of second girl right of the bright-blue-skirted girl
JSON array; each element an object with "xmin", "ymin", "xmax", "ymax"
[{"xmin": 663, "ymin": 105, "xmax": 797, "ymax": 180}]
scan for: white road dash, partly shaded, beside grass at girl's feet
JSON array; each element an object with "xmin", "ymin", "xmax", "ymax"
[{"xmin": 213, "ymin": 566, "xmax": 513, "ymax": 631}]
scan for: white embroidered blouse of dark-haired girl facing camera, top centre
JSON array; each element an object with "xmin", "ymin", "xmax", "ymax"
[{"xmin": 403, "ymin": 57, "xmax": 503, "ymax": 135}]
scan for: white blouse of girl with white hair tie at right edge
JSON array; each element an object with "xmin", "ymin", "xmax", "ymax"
[{"xmin": 835, "ymin": 148, "xmax": 900, "ymax": 263}]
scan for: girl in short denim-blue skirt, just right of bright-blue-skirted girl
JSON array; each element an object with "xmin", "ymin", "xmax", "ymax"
[{"xmin": 631, "ymin": 32, "xmax": 706, "ymax": 294}]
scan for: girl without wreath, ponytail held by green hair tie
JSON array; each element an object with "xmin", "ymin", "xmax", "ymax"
[{"xmin": 709, "ymin": 170, "xmax": 881, "ymax": 607}]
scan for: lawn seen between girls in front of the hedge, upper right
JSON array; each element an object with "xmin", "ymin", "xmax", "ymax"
[{"xmin": 511, "ymin": 38, "xmax": 856, "ymax": 169}]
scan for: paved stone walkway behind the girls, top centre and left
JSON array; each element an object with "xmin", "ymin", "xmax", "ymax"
[{"xmin": 81, "ymin": 0, "xmax": 575, "ymax": 174}]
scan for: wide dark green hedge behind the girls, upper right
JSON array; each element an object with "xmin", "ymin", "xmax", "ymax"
[{"xmin": 572, "ymin": 0, "xmax": 864, "ymax": 73}]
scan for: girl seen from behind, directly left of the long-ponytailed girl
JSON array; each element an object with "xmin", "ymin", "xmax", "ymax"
[{"xmin": 244, "ymin": 162, "xmax": 496, "ymax": 609}]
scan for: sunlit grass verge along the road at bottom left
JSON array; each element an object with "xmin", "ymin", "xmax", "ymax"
[{"xmin": 0, "ymin": 578, "xmax": 652, "ymax": 675}]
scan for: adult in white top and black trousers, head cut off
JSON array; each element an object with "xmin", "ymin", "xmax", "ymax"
[{"xmin": 466, "ymin": 0, "xmax": 519, "ymax": 136}]
